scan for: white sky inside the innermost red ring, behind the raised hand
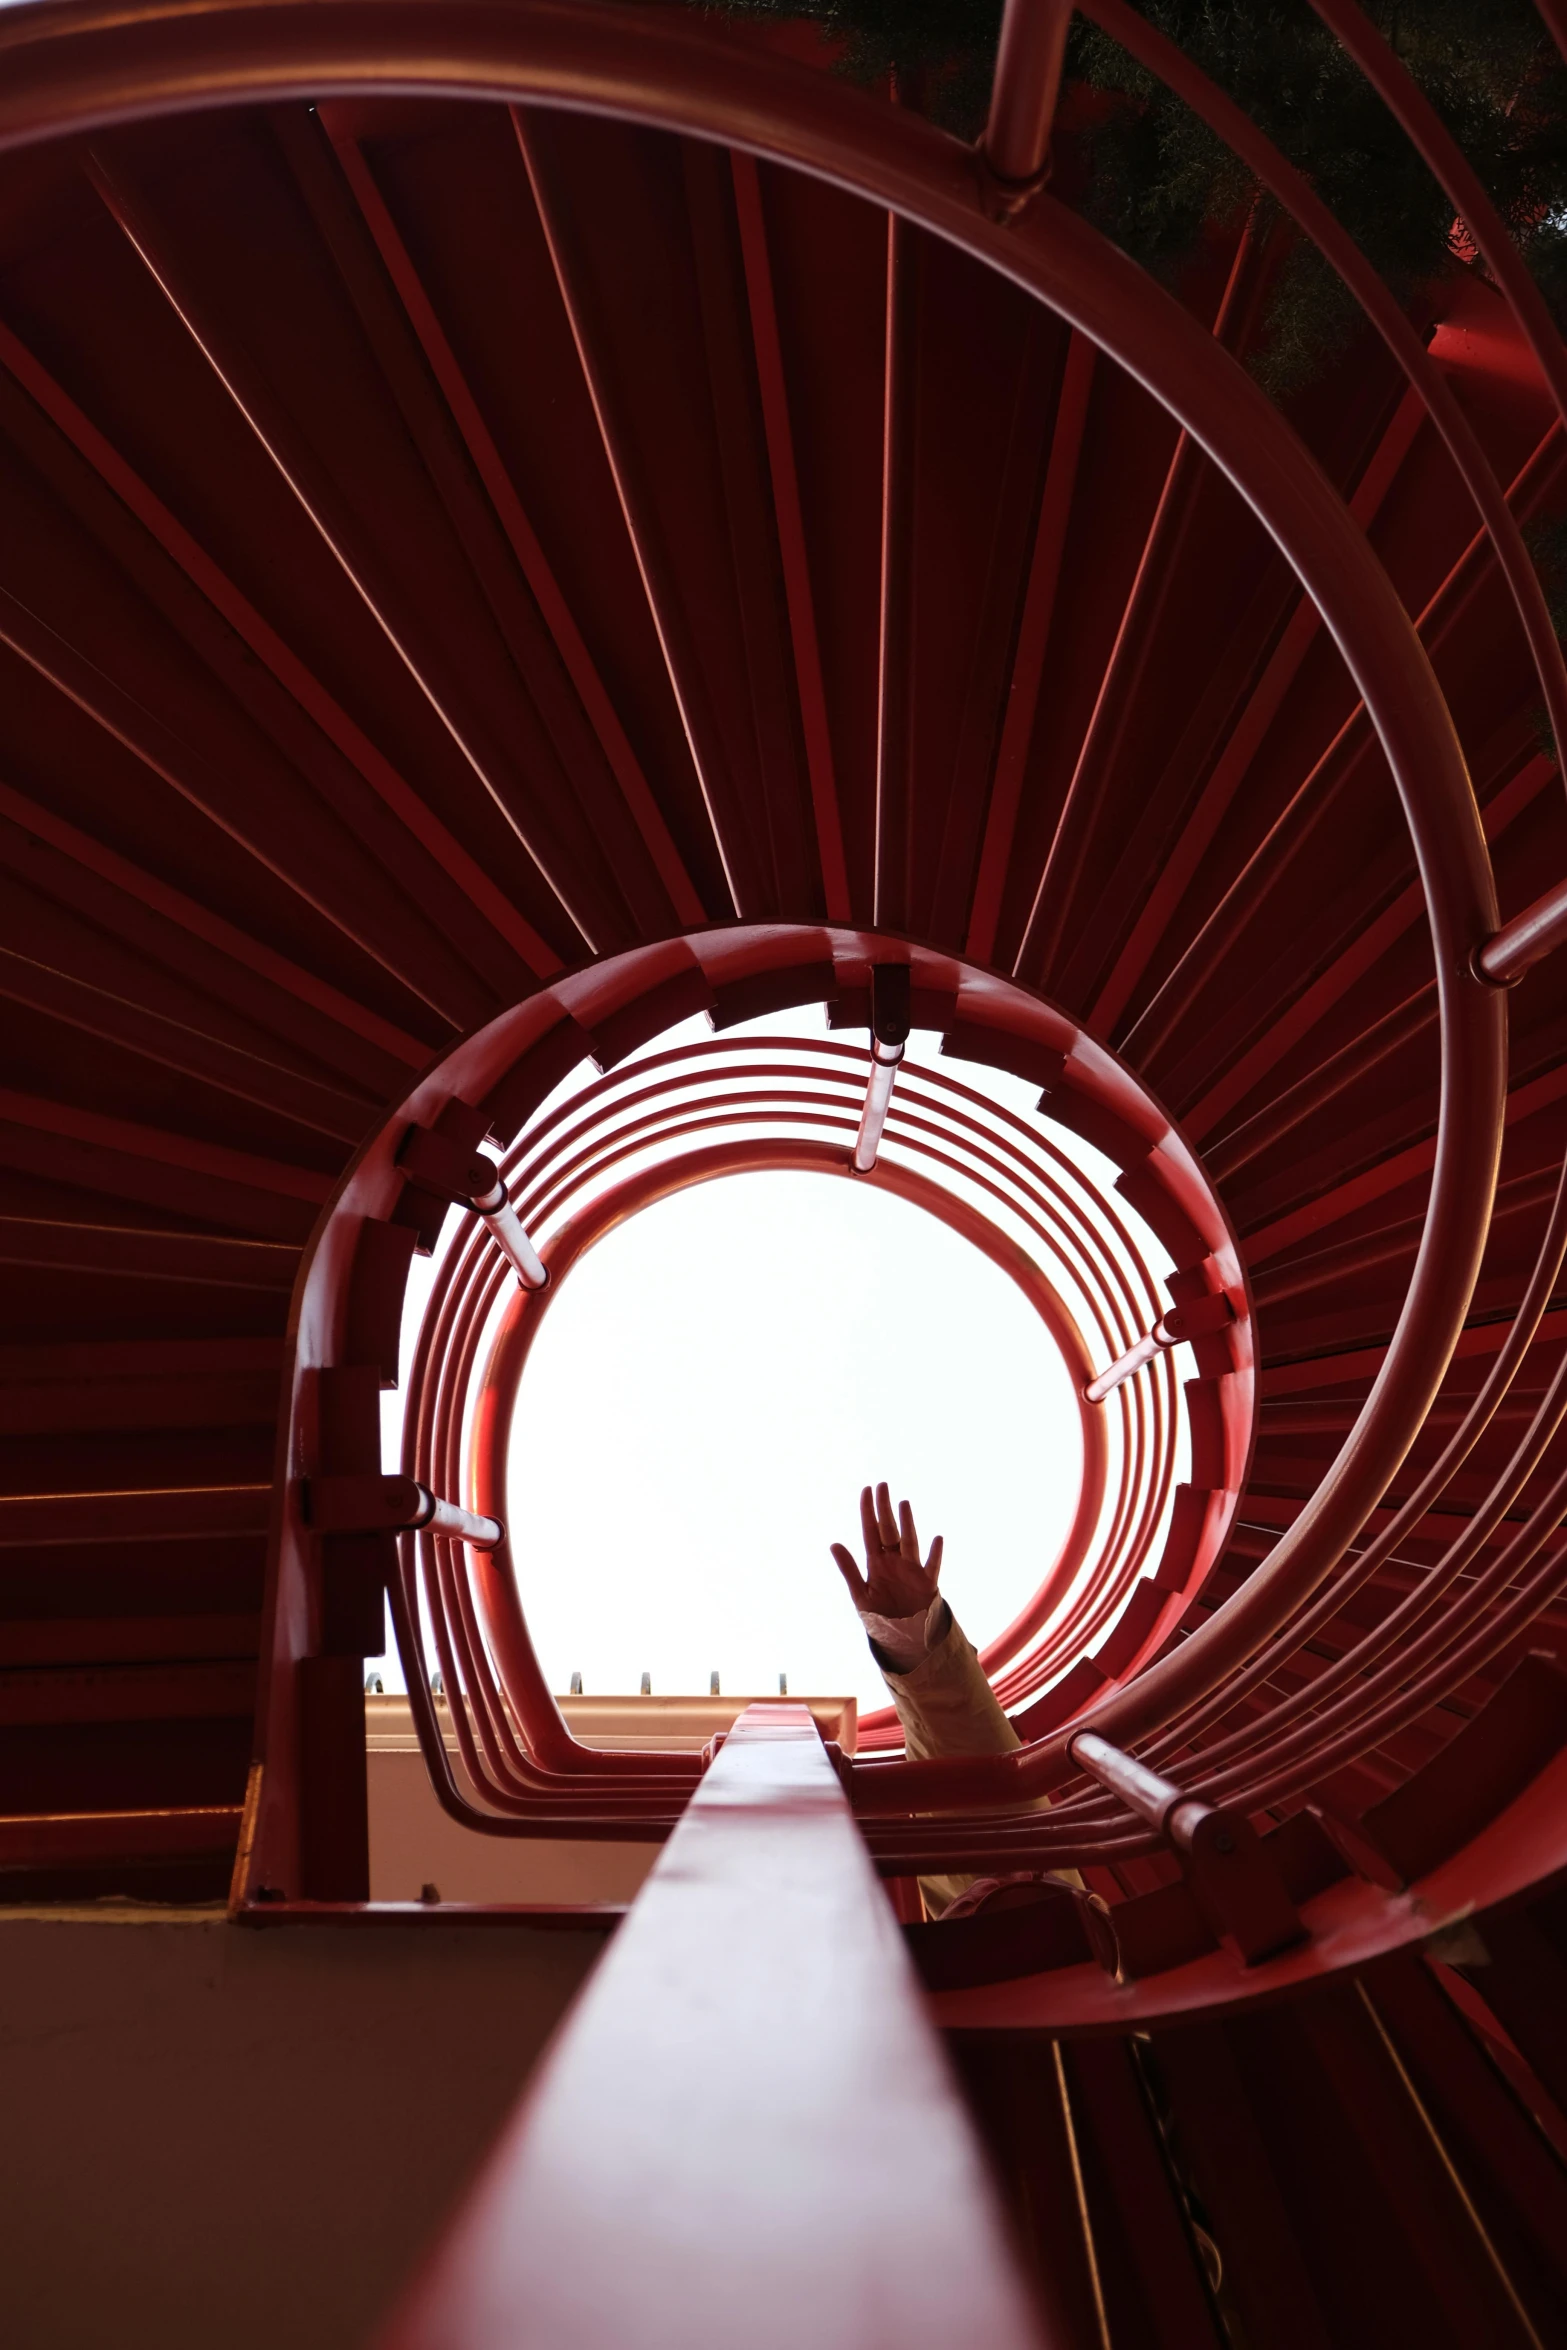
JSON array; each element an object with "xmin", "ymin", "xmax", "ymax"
[{"xmin": 507, "ymin": 1173, "xmax": 1083, "ymax": 1708}]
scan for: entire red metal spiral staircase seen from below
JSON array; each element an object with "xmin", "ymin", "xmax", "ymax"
[{"xmin": 0, "ymin": 0, "xmax": 1567, "ymax": 2350}]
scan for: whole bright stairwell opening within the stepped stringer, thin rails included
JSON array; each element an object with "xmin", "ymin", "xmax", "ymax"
[{"xmin": 388, "ymin": 982, "xmax": 1191, "ymax": 1746}]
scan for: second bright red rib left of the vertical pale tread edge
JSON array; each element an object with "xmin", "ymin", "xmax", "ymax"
[{"xmin": 322, "ymin": 108, "xmax": 705, "ymax": 926}]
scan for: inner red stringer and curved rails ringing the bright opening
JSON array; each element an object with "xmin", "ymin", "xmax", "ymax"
[{"xmin": 244, "ymin": 926, "xmax": 1255, "ymax": 1894}]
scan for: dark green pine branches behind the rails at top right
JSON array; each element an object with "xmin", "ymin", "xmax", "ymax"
[{"xmin": 698, "ymin": 0, "xmax": 1567, "ymax": 395}]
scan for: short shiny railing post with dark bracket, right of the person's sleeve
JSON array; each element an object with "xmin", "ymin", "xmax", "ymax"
[{"xmin": 1067, "ymin": 1730, "xmax": 1306, "ymax": 1967}]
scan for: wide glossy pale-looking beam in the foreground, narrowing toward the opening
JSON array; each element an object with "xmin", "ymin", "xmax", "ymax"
[{"xmin": 383, "ymin": 1706, "xmax": 1055, "ymax": 2350}]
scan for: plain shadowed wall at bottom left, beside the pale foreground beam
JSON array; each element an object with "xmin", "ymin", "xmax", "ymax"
[{"xmin": 0, "ymin": 1911, "xmax": 601, "ymax": 2350}]
